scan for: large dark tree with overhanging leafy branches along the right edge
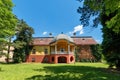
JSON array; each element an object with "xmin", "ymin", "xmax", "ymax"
[{"xmin": 78, "ymin": 0, "xmax": 120, "ymax": 70}]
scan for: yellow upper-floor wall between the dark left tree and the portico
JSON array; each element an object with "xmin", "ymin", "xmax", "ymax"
[{"xmin": 30, "ymin": 46, "xmax": 50, "ymax": 55}]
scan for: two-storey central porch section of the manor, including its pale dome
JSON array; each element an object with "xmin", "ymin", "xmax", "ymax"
[{"xmin": 50, "ymin": 34, "xmax": 75, "ymax": 63}]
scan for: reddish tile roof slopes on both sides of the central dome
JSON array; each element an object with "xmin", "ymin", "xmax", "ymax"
[{"xmin": 32, "ymin": 36, "xmax": 97, "ymax": 46}]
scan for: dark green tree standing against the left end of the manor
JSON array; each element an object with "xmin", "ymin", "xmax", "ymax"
[{"xmin": 13, "ymin": 20, "xmax": 34, "ymax": 63}]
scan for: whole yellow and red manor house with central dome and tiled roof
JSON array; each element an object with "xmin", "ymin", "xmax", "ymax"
[{"xmin": 26, "ymin": 34, "xmax": 97, "ymax": 63}]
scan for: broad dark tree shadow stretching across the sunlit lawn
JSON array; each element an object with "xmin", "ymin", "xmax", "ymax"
[{"xmin": 25, "ymin": 65, "xmax": 120, "ymax": 80}]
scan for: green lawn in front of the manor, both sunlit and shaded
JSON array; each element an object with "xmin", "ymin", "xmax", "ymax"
[{"xmin": 0, "ymin": 63, "xmax": 120, "ymax": 80}]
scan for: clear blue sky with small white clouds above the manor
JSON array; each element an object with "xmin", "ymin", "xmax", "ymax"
[{"xmin": 13, "ymin": 0, "xmax": 102, "ymax": 42}]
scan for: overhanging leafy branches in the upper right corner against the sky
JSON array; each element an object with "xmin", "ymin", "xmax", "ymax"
[{"xmin": 78, "ymin": 0, "xmax": 120, "ymax": 34}]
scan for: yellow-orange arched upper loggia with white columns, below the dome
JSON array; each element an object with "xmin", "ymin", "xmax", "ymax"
[{"xmin": 50, "ymin": 40, "xmax": 75, "ymax": 54}]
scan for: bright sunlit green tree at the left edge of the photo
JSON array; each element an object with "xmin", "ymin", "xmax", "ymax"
[{"xmin": 0, "ymin": 0, "xmax": 17, "ymax": 62}]
